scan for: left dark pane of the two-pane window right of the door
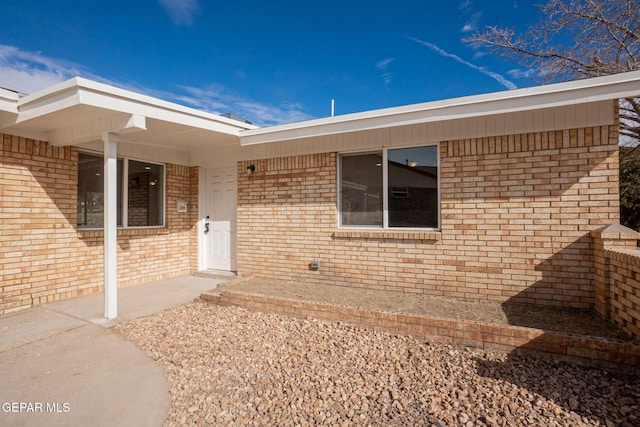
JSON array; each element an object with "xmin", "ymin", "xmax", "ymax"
[{"xmin": 340, "ymin": 152, "xmax": 382, "ymax": 227}]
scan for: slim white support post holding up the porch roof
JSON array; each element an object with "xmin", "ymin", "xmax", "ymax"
[{"xmin": 102, "ymin": 132, "xmax": 118, "ymax": 319}]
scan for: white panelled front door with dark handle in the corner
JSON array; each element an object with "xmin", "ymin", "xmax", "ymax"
[{"xmin": 202, "ymin": 167, "xmax": 237, "ymax": 271}]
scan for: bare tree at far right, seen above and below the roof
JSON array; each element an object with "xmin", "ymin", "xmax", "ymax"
[{"xmin": 463, "ymin": 0, "xmax": 640, "ymax": 228}]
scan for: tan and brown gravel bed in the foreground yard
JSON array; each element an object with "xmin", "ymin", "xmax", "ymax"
[{"xmin": 116, "ymin": 302, "xmax": 640, "ymax": 426}]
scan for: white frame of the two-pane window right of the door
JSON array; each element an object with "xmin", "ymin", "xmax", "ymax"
[{"xmin": 337, "ymin": 143, "xmax": 442, "ymax": 231}]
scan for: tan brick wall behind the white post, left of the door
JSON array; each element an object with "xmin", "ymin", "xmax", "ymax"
[{"xmin": 0, "ymin": 134, "xmax": 198, "ymax": 314}]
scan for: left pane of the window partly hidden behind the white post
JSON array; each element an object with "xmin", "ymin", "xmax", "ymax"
[{"xmin": 77, "ymin": 153, "xmax": 122, "ymax": 228}]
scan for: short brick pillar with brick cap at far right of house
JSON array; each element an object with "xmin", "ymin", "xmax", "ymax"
[{"xmin": 591, "ymin": 224, "xmax": 640, "ymax": 319}]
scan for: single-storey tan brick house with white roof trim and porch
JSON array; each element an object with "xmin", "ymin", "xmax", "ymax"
[{"xmin": 0, "ymin": 72, "xmax": 640, "ymax": 317}]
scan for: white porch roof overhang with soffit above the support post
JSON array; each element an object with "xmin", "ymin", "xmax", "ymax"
[{"xmin": 0, "ymin": 77, "xmax": 254, "ymax": 150}]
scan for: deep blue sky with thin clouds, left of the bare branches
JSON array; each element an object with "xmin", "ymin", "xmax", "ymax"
[{"xmin": 0, "ymin": 0, "xmax": 538, "ymax": 126}]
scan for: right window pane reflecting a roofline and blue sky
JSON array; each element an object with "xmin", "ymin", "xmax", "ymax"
[{"xmin": 388, "ymin": 146, "xmax": 438, "ymax": 228}]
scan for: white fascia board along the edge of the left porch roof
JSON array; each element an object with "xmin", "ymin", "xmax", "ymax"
[{"xmin": 18, "ymin": 77, "xmax": 255, "ymax": 136}]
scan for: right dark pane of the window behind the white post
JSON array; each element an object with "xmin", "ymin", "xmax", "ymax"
[{"xmin": 127, "ymin": 160, "xmax": 164, "ymax": 227}]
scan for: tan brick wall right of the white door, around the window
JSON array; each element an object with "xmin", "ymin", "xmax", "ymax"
[{"xmin": 238, "ymin": 126, "xmax": 619, "ymax": 308}]
